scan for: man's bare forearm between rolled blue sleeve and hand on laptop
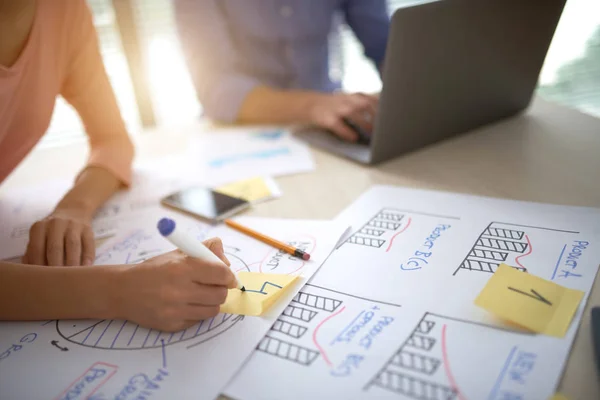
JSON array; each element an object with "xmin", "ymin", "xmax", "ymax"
[{"xmin": 237, "ymin": 86, "xmax": 325, "ymax": 124}]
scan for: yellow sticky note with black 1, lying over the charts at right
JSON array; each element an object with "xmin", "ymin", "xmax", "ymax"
[{"xmin": 475, "ymin": 264, "xmax": 583, "ymax": 337}]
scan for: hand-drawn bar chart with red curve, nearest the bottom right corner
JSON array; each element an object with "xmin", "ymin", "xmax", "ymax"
[{"xmin": 363, "ymin": 312, "xmax": 551, "ymax": 400}]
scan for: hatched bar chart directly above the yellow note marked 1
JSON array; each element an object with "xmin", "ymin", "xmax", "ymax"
[{"xmin": 453, "ymin": 222, "xmax": 578, "ymax": 275}]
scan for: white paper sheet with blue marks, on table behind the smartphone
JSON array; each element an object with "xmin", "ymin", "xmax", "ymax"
[{"xmin": 181, "ymin": 128, "xmax": 315, "ymax": 185}]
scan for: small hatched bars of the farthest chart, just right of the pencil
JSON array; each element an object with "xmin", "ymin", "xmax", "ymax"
[{"xmin": 344, "ymin": 208, "xmax": 410, "ymax": 249}]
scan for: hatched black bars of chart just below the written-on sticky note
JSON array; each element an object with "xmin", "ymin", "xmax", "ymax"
[{"xmin": 257, "ymin": 284, "xmax": 343, "ymax": 366}]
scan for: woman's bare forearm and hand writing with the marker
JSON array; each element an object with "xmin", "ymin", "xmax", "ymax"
[{"xmin": 0, "ymin": 239, "xmax": 237, "ymax": 331}]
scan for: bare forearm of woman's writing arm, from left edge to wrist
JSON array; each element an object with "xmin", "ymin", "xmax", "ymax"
[{"xmin": 0, "ymin": 262, "xmax": 121, "ymax": 321}]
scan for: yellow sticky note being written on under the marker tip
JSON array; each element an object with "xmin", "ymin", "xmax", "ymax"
[{"xmin": 221, "ymin": 272, "xmax": 297, "ymax": 316}]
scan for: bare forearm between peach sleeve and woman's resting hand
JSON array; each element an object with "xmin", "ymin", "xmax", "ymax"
[{"xmin": 56, "ymin": 167, "xmax": 121, "ymax": 219}]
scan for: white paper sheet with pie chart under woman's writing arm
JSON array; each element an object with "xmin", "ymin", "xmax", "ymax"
[{"xmin": 0, "ymin": 211, "xmax": 347, "ymax": 400}]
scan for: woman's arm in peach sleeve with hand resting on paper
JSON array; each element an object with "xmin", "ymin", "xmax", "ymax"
[{"xmin": 23, "ymin": 0, "xmax": 133, "ymax": 266}]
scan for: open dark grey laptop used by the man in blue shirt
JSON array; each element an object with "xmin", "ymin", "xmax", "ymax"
[{"xmin": 294, "ymin": 0, "xmax": 566, "ymax": 164}]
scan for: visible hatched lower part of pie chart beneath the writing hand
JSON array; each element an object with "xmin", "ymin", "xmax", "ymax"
[{"xmin": 56, "ymin": 314, "xmax": 243, "ymax": 350}]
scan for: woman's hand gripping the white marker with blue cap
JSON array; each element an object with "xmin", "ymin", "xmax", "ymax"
[{"xmin": 115, "ymin": 239, "xmax": 236, "ymax": 332}]
